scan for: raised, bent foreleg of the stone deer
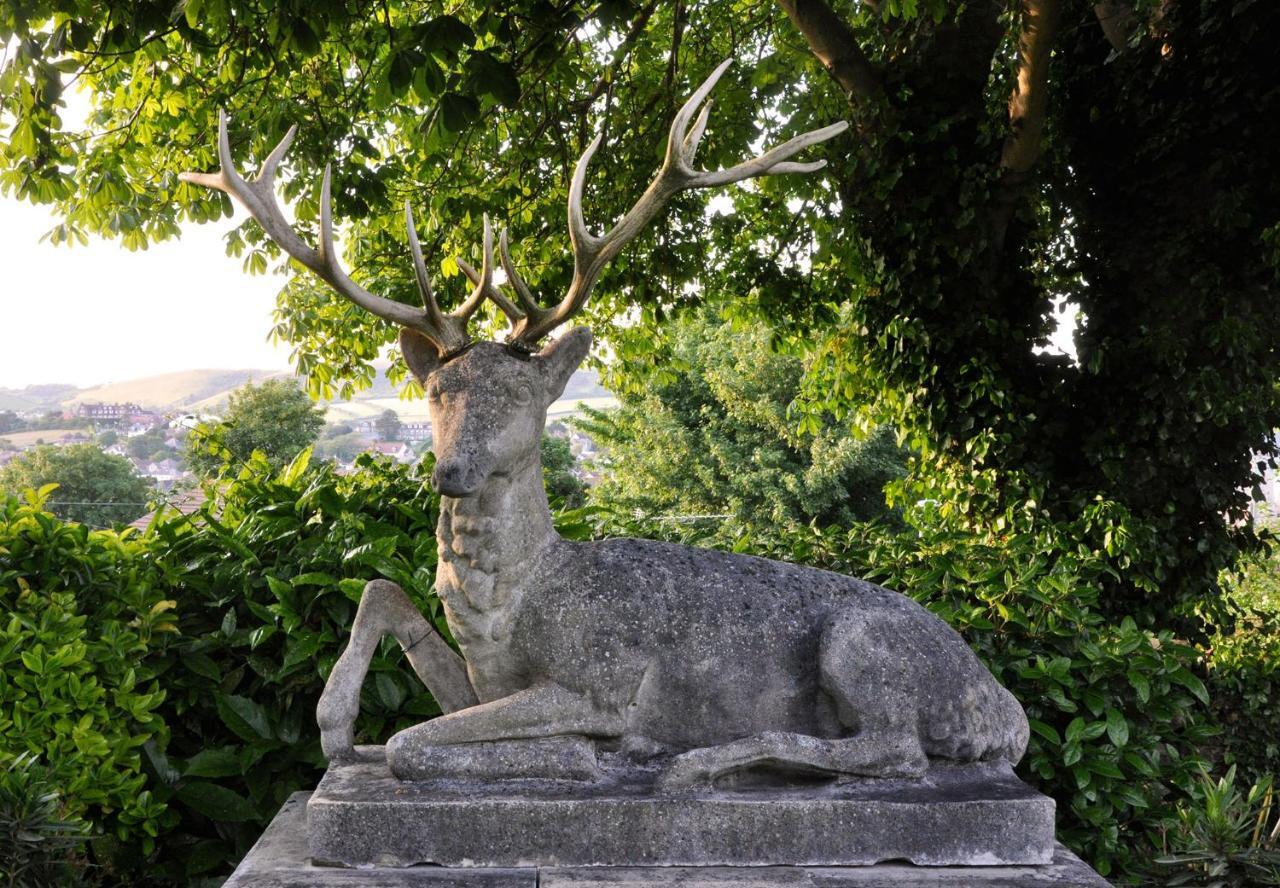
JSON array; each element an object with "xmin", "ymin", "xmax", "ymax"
[{"xmin": 316, "ymin": 580, "xmax": 476, "ymax": 759}]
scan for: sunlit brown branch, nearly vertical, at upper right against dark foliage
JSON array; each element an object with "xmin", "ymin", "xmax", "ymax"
[{"xmin": 1000, "ymin": 0, "xmax": 1061, "ymax": 174}]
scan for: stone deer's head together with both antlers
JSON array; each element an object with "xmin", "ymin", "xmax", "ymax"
[{"xmin": 180, "ymin": 60, "xmax": 849, "ymax": 496}]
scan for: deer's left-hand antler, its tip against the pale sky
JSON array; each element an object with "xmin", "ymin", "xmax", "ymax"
[{"xmin": 178, "ymin": 111, "xmax": 481, "ymax": 360}]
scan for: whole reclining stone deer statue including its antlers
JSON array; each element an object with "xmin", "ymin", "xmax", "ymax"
[{"xmin": 183, "ymin": 61, "xmax": 1028, "ymax": 787}]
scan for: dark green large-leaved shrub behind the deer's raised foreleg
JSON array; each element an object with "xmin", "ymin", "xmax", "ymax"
[{"xmin": 135, "ymin": 450, "xmax": 448, "ymax": 882}]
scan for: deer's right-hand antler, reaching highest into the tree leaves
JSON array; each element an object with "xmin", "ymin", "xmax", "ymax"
[{"xmin": 483, "ymin": 59, "xmax": 849, "ymax": 351}]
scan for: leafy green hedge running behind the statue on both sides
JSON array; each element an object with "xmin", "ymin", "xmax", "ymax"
[{"xmin": 0, "ymin": 456, "xmax": 1277, "ymax": 884}]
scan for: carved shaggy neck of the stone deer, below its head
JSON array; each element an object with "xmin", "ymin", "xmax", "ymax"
[{"xmin": 436, "ymin": 450, "xmax": 559, "ymax": 637}]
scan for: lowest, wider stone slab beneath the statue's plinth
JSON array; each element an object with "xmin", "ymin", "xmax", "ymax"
[{"xmin": 223, "ymin": 792, "xmax": 1111, "ymax": 888}]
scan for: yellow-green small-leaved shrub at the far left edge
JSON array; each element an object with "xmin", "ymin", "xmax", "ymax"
[{"xmin": 0, "ymin": 488, "xmax": 173, "ymax": 880}]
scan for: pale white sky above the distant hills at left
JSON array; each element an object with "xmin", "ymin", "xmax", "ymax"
[{"xmin": 0, "ymin": 197, "xmax": 289, "ymax": 388}]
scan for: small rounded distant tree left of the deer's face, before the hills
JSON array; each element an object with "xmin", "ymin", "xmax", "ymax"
[{"xmin": 186, "ymin": 379, "xmax": 324, "ymax": 477}]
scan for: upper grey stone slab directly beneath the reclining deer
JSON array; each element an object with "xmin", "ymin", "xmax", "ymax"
[{"xmin": 308, "ymin": 754, "xmax": 1053, "ymax": 866}]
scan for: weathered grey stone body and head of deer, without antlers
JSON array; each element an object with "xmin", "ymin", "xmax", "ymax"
[{"xmin": 317, "ymin": 329, "xmax": 1028, "ymax": 787}]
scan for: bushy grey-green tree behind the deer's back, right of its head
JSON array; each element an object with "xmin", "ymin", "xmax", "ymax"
[{"xmin": 579, "ymin": 313, "xmax": 906, "ymax": 540}]
